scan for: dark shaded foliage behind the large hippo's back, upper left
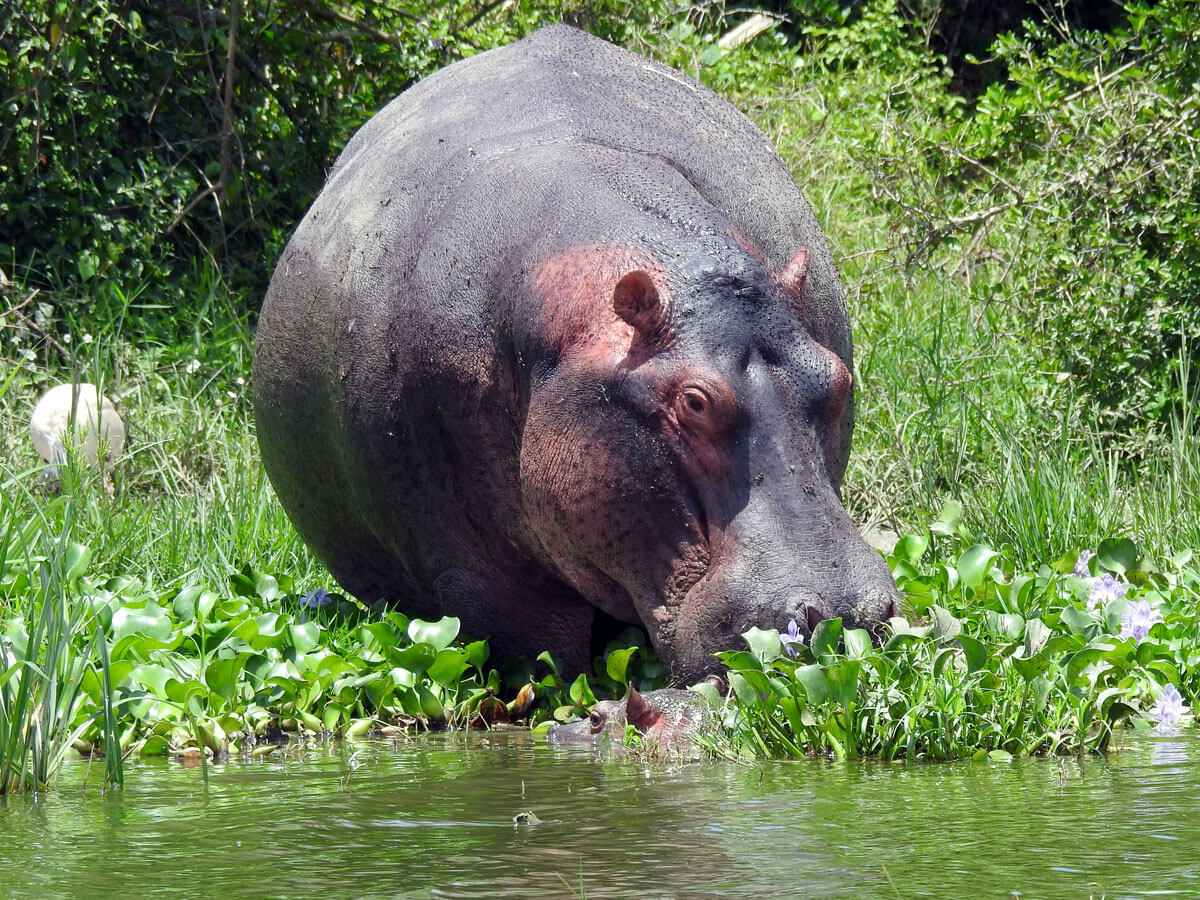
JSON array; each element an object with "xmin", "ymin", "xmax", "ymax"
[{"xmin": 0, "ymin": 0, "xmax": 635, "ymax": 295}]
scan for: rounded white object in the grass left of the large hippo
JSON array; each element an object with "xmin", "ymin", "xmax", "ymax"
[{"xmin": 29, "ymin": 384, "xmax": 125, "ymax": 469}]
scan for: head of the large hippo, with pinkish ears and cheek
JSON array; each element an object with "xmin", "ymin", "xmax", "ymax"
[{"xmin": 522, "ymin": 232, "xmax": 899, "ymax": 683}]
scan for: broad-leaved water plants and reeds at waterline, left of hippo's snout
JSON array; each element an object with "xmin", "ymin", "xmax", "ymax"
[{"xmin": 0, "ymin": 489, "xmax": 664, "ymax": 777}]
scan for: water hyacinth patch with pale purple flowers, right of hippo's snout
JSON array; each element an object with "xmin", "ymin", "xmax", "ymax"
[{"xmin": 712, "ymin": 510, "xmax": 1200, "ymax": 760}]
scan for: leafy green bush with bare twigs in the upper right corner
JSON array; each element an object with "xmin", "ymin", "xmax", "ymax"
[{"xmin": 880, "ymin": 0, "xmax": 1200, "ymax": 427}]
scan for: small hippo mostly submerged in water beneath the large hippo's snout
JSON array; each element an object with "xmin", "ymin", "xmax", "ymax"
[{"xmin": 546, "ymin": 684, "xmax": 716, "ymax": 755}]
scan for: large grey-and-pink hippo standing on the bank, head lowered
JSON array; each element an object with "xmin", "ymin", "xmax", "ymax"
[{"xmin": 253, "ymin": 25, "xmax": 898, "ymax": 684}]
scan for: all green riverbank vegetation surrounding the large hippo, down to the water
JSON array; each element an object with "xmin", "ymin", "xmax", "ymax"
[{"xmin": 0, "ymin": 0, "xmax": 1200, "ymax": 790}]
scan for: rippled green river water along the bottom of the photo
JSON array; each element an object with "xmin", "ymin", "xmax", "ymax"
[{"xmin": 0, "ymin": 732, "xmax": 1200, "ymax": 900}]
